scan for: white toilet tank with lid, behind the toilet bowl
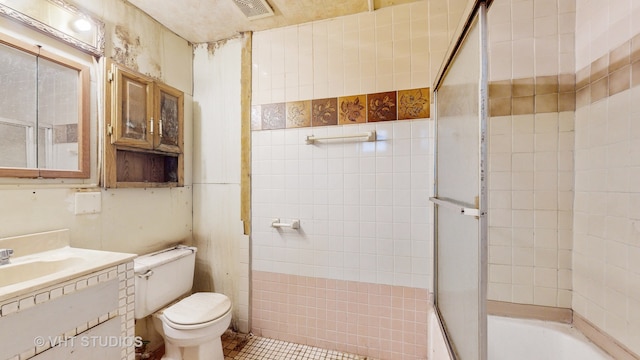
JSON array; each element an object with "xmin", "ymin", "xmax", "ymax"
[{"xmin": 133, "ymin": 245, "xmax": 197, "ymax": 319}]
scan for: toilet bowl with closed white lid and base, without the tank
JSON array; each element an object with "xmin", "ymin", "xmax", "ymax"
[{"xmin": 153, "ymin": 292, "xmax": 231, "ymax": 360}]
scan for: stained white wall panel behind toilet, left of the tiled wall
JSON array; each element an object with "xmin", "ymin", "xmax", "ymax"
[{"xmin": 193, "ymin": 38, "xmax": 249, "ymax": 332}]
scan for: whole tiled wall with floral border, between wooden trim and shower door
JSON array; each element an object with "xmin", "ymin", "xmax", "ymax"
[{"xmin": 252, "ymin": 1, "xmax": 466, "ymax": 359}]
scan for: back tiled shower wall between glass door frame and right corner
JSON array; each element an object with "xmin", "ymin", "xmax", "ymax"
[{"xmin": 488, "ymin": 0, "xmax": 576, "ymax": 308}]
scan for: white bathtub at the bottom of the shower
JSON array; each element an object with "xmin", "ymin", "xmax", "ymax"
[{"xmin": 487, "ymin": 315, "xmax": 613, "ymax": 360}]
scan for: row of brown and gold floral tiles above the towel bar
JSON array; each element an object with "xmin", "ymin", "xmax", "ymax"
[{"xmin": 251, "ymin": 87, "xmax": 431, "ymax": 130}]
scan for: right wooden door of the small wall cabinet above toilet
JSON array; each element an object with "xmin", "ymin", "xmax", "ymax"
[{"xmin": 154, "ymin": 83, "xmax": 184, "ymax": 154}]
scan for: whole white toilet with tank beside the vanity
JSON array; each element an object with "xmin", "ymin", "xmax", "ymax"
[{"xmin": 134, "ymin": 245, "xmax": 231, "ymax": 360}]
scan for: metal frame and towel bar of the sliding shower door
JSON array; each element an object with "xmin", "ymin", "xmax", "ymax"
[{"xmin": 430, "ymin": 0, "xmax": 492, "ymax": 360}]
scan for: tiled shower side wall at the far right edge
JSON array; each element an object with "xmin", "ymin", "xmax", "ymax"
[{"xmin": 573, "ymin": 0, "xmax": 640, "ymax": 355}]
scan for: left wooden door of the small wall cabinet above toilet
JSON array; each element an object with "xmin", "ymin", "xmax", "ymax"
[{"xmin": 111, "ymin": 65, "xmax": 155, "ymax": 149}]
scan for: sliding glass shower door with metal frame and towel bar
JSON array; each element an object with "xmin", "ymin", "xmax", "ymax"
[{"xmin": 431, "ymin": 1, "xmax": 487, "ymax": 360}]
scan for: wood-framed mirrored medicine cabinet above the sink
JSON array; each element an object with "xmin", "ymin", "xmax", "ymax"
[{"xmin": 0, "ymin": 34, "xmax": 89, "ymax": 178}]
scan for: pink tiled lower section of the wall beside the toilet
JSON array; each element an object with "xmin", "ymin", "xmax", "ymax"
[{"xmin": 253, "ymin": 271, "xmax": 430, "ymax": 359}]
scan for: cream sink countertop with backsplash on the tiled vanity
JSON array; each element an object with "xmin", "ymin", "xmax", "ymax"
[{"xmin": 0, "ymin": 229, "xmax": 137, "ymax": 302}]
